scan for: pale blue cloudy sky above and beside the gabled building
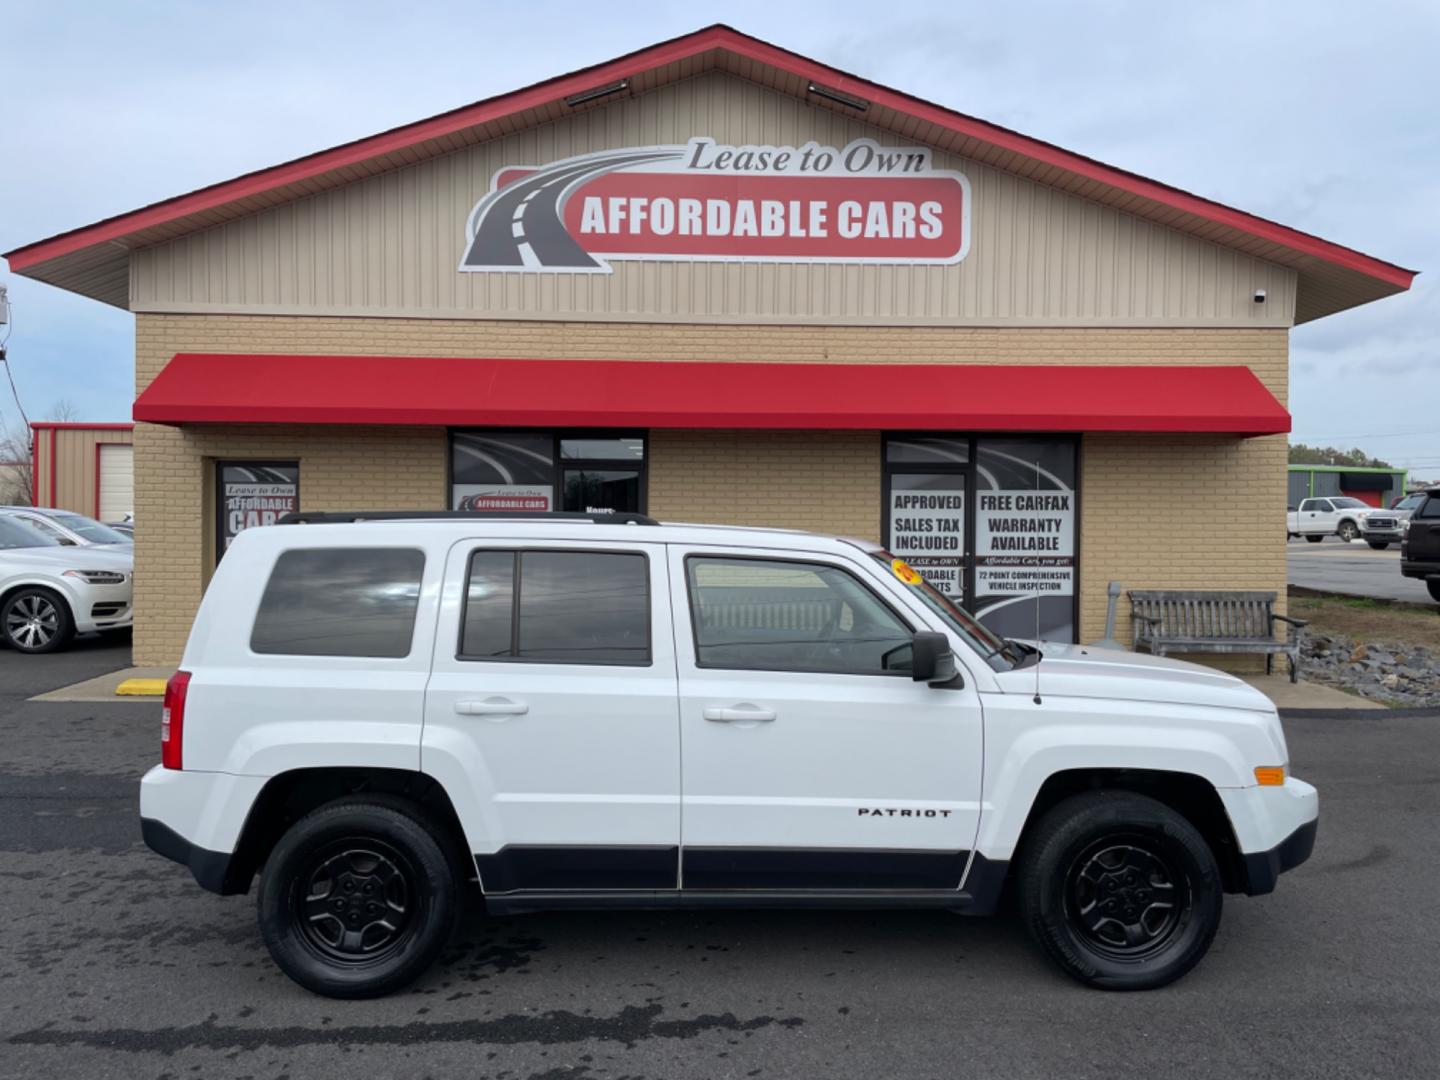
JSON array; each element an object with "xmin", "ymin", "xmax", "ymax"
[{"xmin": 0, "ymin": 0, "xmax": 1440, "ymax": 477}]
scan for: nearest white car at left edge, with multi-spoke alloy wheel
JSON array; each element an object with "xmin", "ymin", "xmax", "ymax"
[{"xmin": 0, "ymin": 514, "xmax": 134, "ymax": 652}]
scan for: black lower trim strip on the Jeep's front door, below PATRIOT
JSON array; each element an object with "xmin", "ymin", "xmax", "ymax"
[{"xmin": 684, "ymin": 847, "xmax": 971, "ymax": 891}]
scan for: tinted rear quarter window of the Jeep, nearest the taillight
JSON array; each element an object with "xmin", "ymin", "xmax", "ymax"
[{"xmin": 251, "ymin": 547, "xmax": 425, "ymax": 658}]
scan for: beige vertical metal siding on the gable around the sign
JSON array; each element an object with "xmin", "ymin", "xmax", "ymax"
[{"xmin": 131, "ymin": 72, "xmax": 1296, "ymax": 327}]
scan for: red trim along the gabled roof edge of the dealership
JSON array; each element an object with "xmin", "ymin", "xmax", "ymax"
[{"xmin": 6, "ymin": 24, "xmax": 1418, "ymax": 288}]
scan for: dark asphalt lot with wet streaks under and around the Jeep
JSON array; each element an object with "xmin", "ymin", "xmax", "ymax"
[{"xmin": 0, "ymin": 642, "xmax": 1440, "ymax": 1080}]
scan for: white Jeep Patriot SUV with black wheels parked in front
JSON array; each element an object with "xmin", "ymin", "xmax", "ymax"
[{"xmin": 140, "ymin": 514, "xmax": 1318, "ymax": 998}]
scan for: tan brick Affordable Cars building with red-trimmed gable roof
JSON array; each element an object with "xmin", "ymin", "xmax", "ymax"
[{"xmin": 7, "ymin": 26, "xmax": 1414, "ymax": 664}]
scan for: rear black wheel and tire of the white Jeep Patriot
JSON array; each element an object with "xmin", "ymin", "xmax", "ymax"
[{"xmin": 256, "ymin": 798, "xmax": 459, "ymax": 998}]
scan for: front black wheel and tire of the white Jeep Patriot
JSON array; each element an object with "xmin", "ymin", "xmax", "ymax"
[{"xmin": 1017, "ymin": 792, "xmax": 1224, "ymax": 991}]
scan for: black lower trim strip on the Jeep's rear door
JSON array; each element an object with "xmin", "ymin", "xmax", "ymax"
[{"xmin": 475, "ymin": 844, "xmax": 680, "ymax": 896}]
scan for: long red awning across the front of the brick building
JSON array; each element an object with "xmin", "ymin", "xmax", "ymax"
[{"xmin": 134, "ymin": 353, "xmax": 1290, "ymax": 435}]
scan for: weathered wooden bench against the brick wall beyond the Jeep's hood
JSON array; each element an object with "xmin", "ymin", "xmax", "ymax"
[{"xmin": 1130, "ymin": 589, "xmax": 1305, "ymax": 683}]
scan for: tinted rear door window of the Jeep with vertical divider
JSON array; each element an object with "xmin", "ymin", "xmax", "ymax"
[{"xmin": 459, "ymin": 550, "xmax": 651, "ymax": 665}]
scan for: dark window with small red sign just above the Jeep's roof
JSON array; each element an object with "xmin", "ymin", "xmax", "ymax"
[{"xmin": 451, "ymin": 431, "xmax": 645, "ymax": 514}]
